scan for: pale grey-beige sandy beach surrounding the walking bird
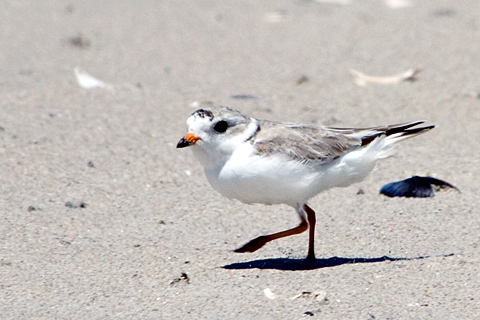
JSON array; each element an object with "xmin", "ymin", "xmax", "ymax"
[{"xmin": 0, "ymin": 0, "xmax": 480, "ymax": 319}]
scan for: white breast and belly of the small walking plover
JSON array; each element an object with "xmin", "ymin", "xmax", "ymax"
[{"xmin": 205, "ymin": 144, "xmax": 376, "ymax": 206}]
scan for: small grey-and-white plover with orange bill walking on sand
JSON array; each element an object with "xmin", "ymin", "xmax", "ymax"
[{"xmin": 177, "ymin": 107, "xmax": 434, "ymax": 259}]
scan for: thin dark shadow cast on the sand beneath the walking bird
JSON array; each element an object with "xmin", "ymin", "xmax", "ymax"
[{"xmin": 221, "ymin": 253, "xmax": 453, "ymax": 271}]
